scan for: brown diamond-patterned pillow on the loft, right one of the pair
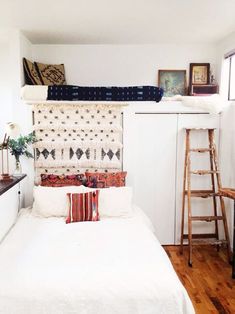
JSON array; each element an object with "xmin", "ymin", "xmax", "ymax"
[{"xmin": 34, "ymin": 62, "xmax": 66, "ymax": 85}]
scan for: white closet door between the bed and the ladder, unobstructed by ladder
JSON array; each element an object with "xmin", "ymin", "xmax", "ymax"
[{"xmin": 132, "ymin": 113, "xmax": 177, "ymax": 244}]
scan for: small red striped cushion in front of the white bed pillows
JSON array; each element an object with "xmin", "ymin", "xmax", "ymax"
[{"xmin": 66, "ymin": 191, "xmax": 99, "ymax": 223}]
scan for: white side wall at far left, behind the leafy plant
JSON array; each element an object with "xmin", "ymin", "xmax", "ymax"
[{"xmin": 0, "ymin": 30, "xmax": 33, "ymax": 206}]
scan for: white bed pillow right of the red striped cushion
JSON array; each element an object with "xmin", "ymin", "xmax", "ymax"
[{"xmin": 99, "ymin": 186, "xmax": 134, "ymax": 218}]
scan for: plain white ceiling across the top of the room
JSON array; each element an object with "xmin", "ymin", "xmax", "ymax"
[{"xmin": 0, "ymin": 0, "xmax": 235, "ymax": 44}]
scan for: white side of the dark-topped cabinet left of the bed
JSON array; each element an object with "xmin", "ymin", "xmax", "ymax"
[{"xmin": 0, "ymin": 184, "xmax": 19, "ymax": 241}]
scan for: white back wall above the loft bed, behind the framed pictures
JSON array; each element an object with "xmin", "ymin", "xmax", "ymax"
[{"xmin": 32, "ymin": 44, "xmax": 216, "ymax": 86}]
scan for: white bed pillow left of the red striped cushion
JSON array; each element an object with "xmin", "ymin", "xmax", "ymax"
[{"xmin": 32, "ymin": 185, "xmax": 85, "ymax": 217}]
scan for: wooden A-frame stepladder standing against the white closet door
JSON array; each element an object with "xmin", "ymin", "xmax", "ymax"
[{"xmin": 180, "ymin": 128, "xmax": 231, "ymax": 266}]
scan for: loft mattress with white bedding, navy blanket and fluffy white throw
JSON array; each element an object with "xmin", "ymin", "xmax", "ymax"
[{"xmin": 21, "ymin": 85, "xmax": 226, "ymax": 114}]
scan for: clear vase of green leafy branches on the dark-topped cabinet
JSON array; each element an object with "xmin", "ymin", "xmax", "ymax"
[{"xmin": 9, "ymin": 133, "xmax": 36, "ymax": 176}]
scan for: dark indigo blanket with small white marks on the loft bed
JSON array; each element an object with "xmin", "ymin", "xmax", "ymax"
[{"xmin": 47, "ymin": 85, "xmax": 163, "ymax": 102}]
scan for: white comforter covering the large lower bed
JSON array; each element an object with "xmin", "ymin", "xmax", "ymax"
[{"xmin": 0, "ymin": 210, "xmax": 194, "ymax": 314}]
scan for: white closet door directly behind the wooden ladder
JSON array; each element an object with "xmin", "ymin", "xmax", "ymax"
[{"xmin": 175, "ymin": 114, "xmax": 220, "ymax": 244}]
